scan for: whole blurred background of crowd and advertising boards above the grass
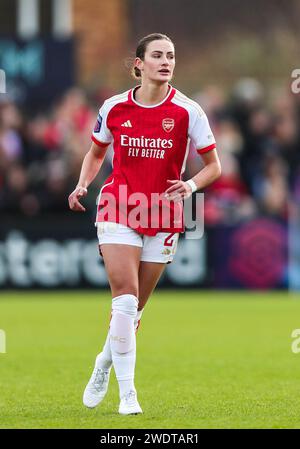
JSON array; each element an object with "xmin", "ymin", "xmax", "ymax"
[{"xmin": 0, "ymin": 0, "xmax": 300, "ymax": 290}]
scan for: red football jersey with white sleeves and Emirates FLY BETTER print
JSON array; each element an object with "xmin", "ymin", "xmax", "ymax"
[{"xmin": 92, "ymin": 86, "xmax": 216, "ymax": 236}]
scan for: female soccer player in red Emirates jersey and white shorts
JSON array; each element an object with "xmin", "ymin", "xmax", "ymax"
[{"xmin": 69, "ymin": 33, "xmax": 221, "ymax": 415}]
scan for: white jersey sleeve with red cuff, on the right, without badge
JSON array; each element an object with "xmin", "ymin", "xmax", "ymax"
[{"xmin": 189, "ymin": 105, "xmax": 216, "ymax": 154}]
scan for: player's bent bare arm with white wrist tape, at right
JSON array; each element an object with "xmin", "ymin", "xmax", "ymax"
[{"xmin": 165, "ymin": 148, "xmax": 221, "ymax": 201}]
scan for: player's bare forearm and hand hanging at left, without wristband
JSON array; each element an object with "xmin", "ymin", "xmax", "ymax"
[{"xmin": 68, "ymin": 142, "xmax": 109, "ymax": 212}]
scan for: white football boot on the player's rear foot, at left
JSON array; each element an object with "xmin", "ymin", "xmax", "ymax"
[{"xmin": 83, "ymin": 356, "xmax": 111, "ymax": 408}]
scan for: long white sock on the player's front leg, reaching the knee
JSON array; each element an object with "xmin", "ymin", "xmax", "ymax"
[{"xmin": 109, "ymin": 294, "xmax": 138, "ymax": 398}]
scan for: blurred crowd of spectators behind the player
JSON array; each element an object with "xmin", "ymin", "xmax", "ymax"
[{"xmin": 0, "ymin": 79, "xmax": 300, "ymax": 225}]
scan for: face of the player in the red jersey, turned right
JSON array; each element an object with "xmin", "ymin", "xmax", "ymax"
[{"xmin": 136, "ymin": 40, "xmax": 175, "ymax": 83}]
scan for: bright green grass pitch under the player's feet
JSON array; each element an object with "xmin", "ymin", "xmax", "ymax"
[{"xmin": 0, "ymin": 290, "xmax": 300, "ymax": 429}]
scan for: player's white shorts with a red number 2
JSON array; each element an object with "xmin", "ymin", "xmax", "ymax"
[{"xmin": 97, "ymin": 221, "xmax": 179, "ymax": 263}]
